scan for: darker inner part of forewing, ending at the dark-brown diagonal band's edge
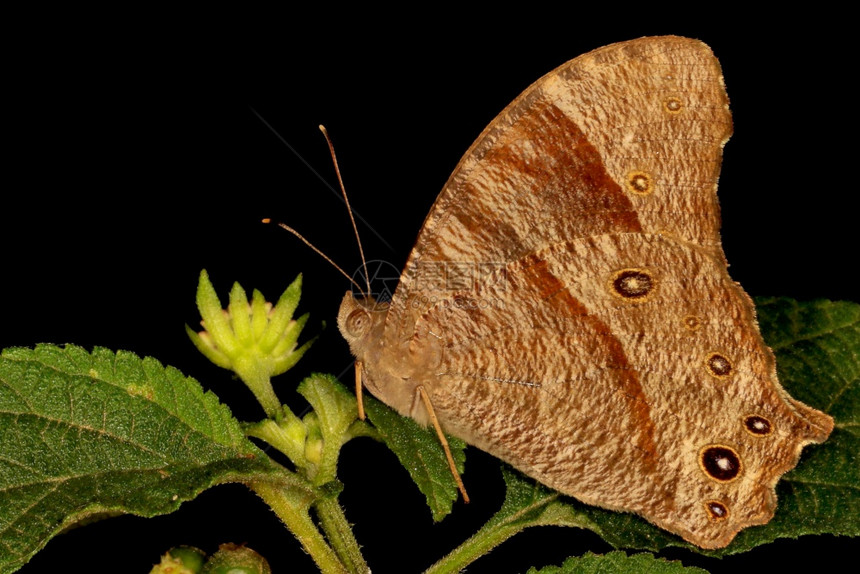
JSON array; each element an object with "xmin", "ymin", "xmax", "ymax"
[{"xmin": 394, "ymin": 100, "xmax": 642, "ymax": 333}]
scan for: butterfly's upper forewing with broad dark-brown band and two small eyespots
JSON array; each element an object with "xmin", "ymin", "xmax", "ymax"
[{"xmin": 388, "ymin": 37, "xmax": 731, "ymax": 338}]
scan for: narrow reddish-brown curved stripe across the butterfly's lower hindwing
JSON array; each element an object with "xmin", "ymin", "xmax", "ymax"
[{"xmin": 517, "ymin": 254, "xmax": 657, "ymax": 472}]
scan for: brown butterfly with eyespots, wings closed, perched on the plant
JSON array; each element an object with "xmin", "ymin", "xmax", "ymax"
[{"xmin": 338, "ymin": 37, "xmax": 833, "ymax": 548}]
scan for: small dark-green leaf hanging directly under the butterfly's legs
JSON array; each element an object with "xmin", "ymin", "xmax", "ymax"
[{"xmin": 364, "ymin": 395, "xmax": 466, "ymax": 522}]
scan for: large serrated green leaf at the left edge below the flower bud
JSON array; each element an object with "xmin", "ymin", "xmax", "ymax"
[{"xmin": 0, "ymin": 345, "xmax": 284, "ymax": 573}]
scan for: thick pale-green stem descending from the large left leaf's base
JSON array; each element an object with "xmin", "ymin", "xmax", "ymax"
[{"xmin": 248, "ymin": 482, "xmax": 349, "ymax": 574}]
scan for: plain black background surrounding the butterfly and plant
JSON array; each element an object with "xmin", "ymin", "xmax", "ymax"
[{"xmin": 0, "ymin": 12, "xmax": 858, "ymax": 574}]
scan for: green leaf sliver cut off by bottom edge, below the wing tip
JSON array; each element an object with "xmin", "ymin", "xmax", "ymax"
[{"xmin": 527, "ymin": 552, "xmax": 707, "ymax": 574}]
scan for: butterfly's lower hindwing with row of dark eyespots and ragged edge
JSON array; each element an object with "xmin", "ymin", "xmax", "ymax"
[{"xmin": 409, "ymin": 233, "xmax": 830, "ymax": 547}]
